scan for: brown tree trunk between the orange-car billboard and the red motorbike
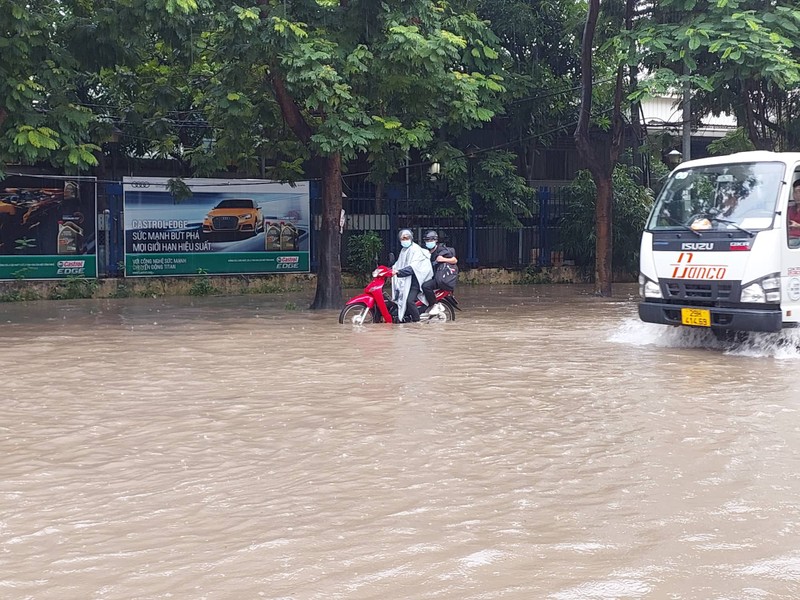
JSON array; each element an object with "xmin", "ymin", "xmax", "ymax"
[{"xmin": 311, "ymin": 153, "xmax": 342, "ymax": 309}]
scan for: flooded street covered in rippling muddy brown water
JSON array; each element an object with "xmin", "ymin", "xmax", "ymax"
[{"xmin": 0, "ymin": 285, "xmax": 800, "ymax": 600}]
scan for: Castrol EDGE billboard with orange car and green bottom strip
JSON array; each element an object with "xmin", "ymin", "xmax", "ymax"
[{"xmin": 123, "ymin": 177, "xmax": 310, "ymax": 277}]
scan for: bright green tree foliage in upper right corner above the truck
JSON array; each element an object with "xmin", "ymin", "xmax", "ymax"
[{"xmin": 629, "ymin": 0, "xmax": 800, "ymax": 149}]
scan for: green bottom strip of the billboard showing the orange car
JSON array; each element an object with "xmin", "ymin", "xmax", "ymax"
[{"xmin": 125, "ymin": 252, "xmax": 309, "ymax": 277}]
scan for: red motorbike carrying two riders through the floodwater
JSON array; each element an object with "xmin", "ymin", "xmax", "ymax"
[{"xmin": 339, "ymin": 266, "xmax": 461, "ymax": 325}]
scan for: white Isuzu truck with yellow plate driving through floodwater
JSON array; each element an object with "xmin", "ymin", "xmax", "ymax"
[{"xmin": 639, "ymin": 151, "xmax": 800, "ymax": 338}]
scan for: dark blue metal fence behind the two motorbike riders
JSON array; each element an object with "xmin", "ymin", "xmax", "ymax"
[{"xmin": 311, "ymin": 186, "xmax": 566, "ymax": 269}]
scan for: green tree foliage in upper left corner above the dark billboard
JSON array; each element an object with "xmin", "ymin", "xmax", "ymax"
[{"xmin": 0, "ymin": 0, "xmax": 207, "ymax": 178}]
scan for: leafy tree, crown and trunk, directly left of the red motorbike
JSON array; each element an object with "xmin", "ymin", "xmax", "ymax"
[{"xmin": 194, "ymin": 0, "xmax": 504, "ymax": 308}]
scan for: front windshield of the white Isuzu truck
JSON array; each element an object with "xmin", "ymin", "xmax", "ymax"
[{"xmin": 647, "ymin": 162, "xmax": 785, "ymax": 232}]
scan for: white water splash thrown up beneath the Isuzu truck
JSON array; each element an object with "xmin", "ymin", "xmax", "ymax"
[{"xmin": 608, "ymin": 319, "xmax": 800, "ymax": 360}]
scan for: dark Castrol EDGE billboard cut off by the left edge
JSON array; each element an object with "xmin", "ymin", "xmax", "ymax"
[{"xmin": 0, "ymin": 175, "xmax": 97, "ymax": 279}]
